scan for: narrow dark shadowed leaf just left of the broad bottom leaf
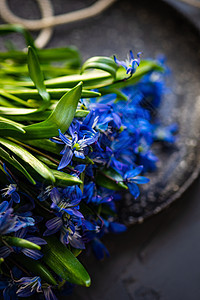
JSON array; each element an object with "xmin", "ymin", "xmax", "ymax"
[{"xmin": 14, "ymin": 254, "xmax": 57, "ymax": 285}]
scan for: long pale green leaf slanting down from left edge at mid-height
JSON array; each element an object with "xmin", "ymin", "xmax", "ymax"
[{"xmin": 0, "ymin": 138, "xmax": 55, "ymax": 182}]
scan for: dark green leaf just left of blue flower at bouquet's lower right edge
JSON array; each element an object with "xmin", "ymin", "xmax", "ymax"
[{"xmin": 95, "ymin": 168, "xmax": 128, "ymax": 191}]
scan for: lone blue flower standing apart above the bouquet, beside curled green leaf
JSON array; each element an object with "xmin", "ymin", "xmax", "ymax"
[{"xmin": 114, "ymin": 50, "xmax": 141, "ymax": 76}]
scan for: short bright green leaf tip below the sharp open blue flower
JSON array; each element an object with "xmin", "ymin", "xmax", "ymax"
[{"xmin": 51, "ymin": 170, "xmax": 83, "ymax": 187}]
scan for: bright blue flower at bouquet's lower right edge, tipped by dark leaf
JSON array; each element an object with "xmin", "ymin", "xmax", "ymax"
[{"xmin": 124, "ymin": 166, "xmax": 149, "ymax": 199}]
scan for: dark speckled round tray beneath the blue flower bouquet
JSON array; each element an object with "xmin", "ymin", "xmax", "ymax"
[{"xmin": 47, "ymin": 0, "xmax": 200, "ymax": 225}]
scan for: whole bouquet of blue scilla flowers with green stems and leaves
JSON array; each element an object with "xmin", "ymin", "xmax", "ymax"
[{"xmin": 0, "ymin": 25, "xmax": 177, "ymax": 299}]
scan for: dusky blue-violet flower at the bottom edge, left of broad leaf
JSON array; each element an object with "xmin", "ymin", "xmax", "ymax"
[{"xmin": 16, "ymin": 276, "xmax": 42, "ymax": 297}]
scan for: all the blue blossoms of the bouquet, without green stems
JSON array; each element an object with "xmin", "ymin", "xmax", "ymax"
[{"xmin": 0, "ymin": 52, "xmax": 177, "ymax": 300}]
